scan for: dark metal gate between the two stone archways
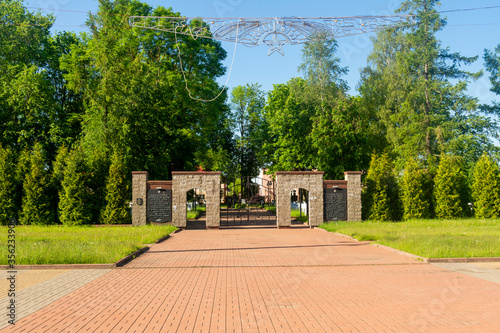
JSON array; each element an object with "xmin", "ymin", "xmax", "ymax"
[{"xmin": 220, "ymin": 177, "xmax": 276, "ymax": 227}]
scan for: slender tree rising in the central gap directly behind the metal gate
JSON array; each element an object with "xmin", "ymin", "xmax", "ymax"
[{"xmin": 231, "ymin": 83, "xmax": 266, "ymax": 176}]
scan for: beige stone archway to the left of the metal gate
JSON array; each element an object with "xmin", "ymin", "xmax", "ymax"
[{"xmin": 172, "ymin": 171, "xmax": 221, "ymax": 228}]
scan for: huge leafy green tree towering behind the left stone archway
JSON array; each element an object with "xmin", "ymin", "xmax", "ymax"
[{"xmin": 62, "ymin": 0, "xmax": 229, "ymax": 179}]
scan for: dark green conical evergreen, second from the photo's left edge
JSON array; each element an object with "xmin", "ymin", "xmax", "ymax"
[{"xmin": 20, "ymin": 143, "xmax": 54, "ymax": 225}]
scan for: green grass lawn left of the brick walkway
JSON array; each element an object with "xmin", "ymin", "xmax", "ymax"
[{"xmin": 0, "ymin": 226, "xmax": 176, "ymax": 265}]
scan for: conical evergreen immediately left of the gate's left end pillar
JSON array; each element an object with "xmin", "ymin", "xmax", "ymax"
[{"xmin": 101, "ymin": 152, "xmax": 131, "ymax": 224}]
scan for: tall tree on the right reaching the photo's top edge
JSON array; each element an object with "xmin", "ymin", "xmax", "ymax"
[{"xmin": 360, "ymin": 0, "xmax": 496, "ymax": 168}]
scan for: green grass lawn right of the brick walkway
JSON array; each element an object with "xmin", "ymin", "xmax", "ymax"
[{"xmin": 321, "ymin": 219, "xmax": 500, "ymax": 258}]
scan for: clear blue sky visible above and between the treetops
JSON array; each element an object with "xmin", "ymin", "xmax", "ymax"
[{"xmin": 25, "ymin": 0, "xmax": 500, "ymax": 103}]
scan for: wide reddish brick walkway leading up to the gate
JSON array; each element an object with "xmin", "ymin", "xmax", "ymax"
[{"xmin": 2, "ymin": 228, "xmax": 500, "ymax": 332}]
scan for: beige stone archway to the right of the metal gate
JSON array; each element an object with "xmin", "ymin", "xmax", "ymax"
[{"xmin": 276, "ymin": 171, "xmax": 324, "ymax": 228}]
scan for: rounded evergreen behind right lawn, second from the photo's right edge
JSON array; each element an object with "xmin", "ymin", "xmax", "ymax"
[{"xmin": 434, "ymin": 155, "xmax": 469, "ymax": 219}]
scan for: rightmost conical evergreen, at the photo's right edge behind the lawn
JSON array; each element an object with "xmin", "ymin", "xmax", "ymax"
[{"xmin": 472, "ymin": 154, "xmax": 500, "ymax": 218}]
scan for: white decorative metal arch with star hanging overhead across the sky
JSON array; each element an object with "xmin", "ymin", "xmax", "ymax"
[{"xmin": 129, "ymin": 15, "xmax": 415, "ymax": 55}]
